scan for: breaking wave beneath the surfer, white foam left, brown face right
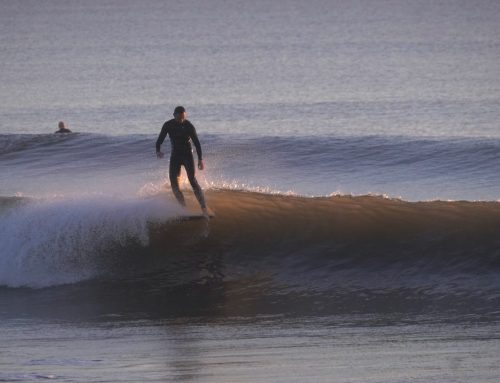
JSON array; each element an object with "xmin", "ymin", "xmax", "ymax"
[{"xmin": 0, "ymin": 190, "xmax": 500, "ymax": 296}]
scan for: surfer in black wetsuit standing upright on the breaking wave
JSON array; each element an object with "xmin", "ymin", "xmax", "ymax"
[{"xmin": 156, "ymin": 106, "xmax": 209, "ymax": 216}]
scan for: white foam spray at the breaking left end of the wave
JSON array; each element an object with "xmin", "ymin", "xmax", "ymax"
[{"xmin": 0, "ymin": 195, "xmax": 183, "ymax": 287}]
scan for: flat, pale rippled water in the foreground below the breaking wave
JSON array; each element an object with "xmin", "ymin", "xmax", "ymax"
[{"xmin": 0, "ymin": 315, "xmax": 500, "ymax": 383}]
